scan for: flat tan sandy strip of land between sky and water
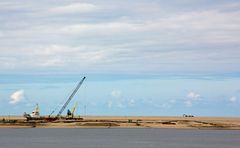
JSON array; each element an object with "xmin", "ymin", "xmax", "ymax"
[{"xmin": 0, "ymin": 116, "xmax": 240, "ymax": 129}]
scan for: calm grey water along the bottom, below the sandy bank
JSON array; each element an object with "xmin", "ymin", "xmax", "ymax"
[{"xmin": 0, "ymin": 129, "xmax": 240, "ymax": 148}]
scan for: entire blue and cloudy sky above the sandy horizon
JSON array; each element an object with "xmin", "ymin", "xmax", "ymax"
[{"xmin": 0, "ymin": 0, "xmax": 240, "ymax": 116}]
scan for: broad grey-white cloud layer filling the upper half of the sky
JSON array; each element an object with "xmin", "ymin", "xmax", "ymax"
[{"xmin": 0, "ymin": 0, "xmax": 240, "ymax": 74}]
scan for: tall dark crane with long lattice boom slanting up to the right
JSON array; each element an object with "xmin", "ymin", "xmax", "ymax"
[{"xmin": 49, "ymin": 77, "xmax": 86, "ymax": 120}]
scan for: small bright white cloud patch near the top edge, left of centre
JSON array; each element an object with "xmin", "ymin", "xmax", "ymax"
[{"xmin": 50, "ymin": 3, "xmax": 97, "ymax": 14}]
